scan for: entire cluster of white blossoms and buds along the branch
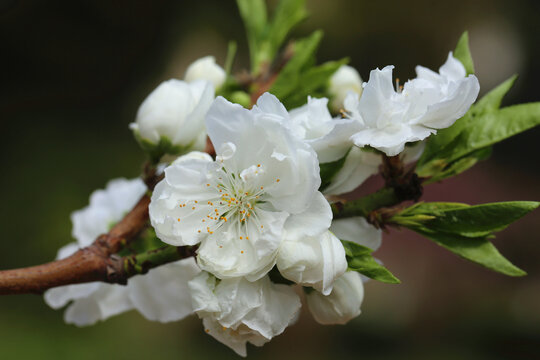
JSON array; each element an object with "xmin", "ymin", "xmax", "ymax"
[{"xmin": 45, "ymin": 54, "xmax": 478, "ymax": 355}]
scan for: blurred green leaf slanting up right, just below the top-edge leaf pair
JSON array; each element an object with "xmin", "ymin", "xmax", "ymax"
[{"xmin": 270, "ymin": 30, "xmax": 323, "ymax": 99}]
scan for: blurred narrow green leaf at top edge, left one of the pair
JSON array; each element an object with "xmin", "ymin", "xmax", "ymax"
[{"xmin": 236, "ymin": 0, "xmax": 268, "ymax": 70}]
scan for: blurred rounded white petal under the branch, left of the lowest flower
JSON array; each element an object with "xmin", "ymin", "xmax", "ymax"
[{"xmin": 128, "ymin": 258, "xmax": 200, "ymax": 322}]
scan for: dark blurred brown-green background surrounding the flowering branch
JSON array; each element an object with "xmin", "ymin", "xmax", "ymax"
[{"xmin": 0, "ymin": 0, "xmax": 540, "ymax": 359}]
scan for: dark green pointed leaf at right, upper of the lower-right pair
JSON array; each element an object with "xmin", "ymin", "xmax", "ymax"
[{"xmin": 393, "ymin": 201, "xmax": 540, "ymax": 238}]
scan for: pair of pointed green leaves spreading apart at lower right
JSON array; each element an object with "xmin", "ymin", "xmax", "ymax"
[{"xmin": 390, "ymin": 201, "xmax": 540, "ymax": 276}]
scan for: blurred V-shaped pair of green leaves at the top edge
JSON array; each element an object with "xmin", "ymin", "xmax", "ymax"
[{"xmin": 236, "ymin": 0, "xmax": 307, "ymax": 75}]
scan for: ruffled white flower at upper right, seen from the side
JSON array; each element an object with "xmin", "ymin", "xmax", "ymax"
[{"xmin": 345, "ymin": 53, "xmax": 480, "ymax": 156}]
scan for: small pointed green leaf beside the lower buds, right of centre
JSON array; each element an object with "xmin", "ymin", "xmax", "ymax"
[{"xmin": 341, "ymin": 240, "xmax": 400, "ymax": 284}]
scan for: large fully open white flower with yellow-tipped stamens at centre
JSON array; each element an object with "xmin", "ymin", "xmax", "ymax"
[{"xmin": 149, "ymin": 94, "xmax": 332, "ymax": 280}]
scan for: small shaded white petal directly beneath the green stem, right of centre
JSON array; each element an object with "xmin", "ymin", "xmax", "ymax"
[{"xmin": 330, "ymin": 216, "xmax": 382, "ymax": 251}]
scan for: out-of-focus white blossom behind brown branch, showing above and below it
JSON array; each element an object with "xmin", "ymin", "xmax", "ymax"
[{"xmin": 45, "ymin": 179, "xmax": 200, "ymax": 326}]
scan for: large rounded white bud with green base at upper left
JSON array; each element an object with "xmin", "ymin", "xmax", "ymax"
[{"xmin": 130, "ymin": 79, "xmax": 214, "ymax": 154}]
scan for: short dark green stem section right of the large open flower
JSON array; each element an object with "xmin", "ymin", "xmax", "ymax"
[{"xmin": 332, "ymin": 188, "xmax": 402, "ymax": 219}]
